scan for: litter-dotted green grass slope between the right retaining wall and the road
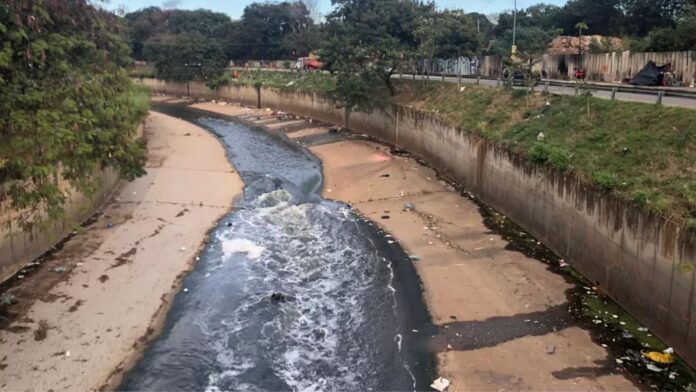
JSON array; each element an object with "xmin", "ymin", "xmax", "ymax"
[{"xmin": 216, "ymin": 71, "xmax": 696, "ymax": 230}]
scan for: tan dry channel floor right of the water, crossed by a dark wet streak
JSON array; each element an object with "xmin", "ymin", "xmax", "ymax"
[{"xmin": 179, "ymin": 97, "xmax": 636, "ymax": 391}]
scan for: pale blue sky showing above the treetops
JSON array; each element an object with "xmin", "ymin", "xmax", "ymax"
[{"xmin": 106, "ymin": 0, "xmax": 566, "ymax": 19}]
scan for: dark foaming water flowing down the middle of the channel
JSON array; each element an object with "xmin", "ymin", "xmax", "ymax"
[{"xmin": 120, "ymin": 105, "xmax": 432, "ymax": 391}]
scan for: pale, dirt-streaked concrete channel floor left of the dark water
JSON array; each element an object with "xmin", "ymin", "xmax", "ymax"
[{"xmin": 0, "ymin": 113, "xmax": 243, "ymax": 391}]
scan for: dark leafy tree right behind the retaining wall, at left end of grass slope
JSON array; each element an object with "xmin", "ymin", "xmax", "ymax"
[{"xmin": 321, "ymin": 0, "xmax": 434, "ymax": 109}]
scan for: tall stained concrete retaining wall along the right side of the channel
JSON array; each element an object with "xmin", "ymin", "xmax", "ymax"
[{"xmin": 137, "ymin": 79, "xmax": 696, "ymax": 366}]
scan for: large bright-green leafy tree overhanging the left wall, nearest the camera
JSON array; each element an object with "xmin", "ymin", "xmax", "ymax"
[{"xmin": 0, "ymin": 0, "xmax": 148, "ymax": 227}]
